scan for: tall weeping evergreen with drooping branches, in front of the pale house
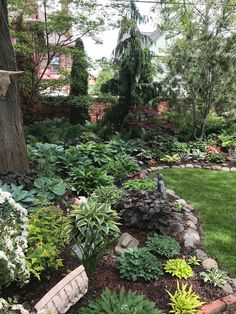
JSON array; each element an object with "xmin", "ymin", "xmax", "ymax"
[{"xmin": 105, "ymin": 0, "xmax": 157, "ymax": 127}]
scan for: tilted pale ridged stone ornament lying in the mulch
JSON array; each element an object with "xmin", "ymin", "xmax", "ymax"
[{"xmin": 35, "ymin": 265, "xmax": 88, "ymax": 314}]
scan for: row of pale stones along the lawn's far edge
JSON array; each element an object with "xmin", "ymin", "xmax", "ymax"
[{"xmin": 148, "ymin": 163, "xmax": 236, "ymax": 172}]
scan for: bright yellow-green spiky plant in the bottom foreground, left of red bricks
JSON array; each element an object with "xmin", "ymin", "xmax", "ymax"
[{"xmin": 167, "ymin": 282, "xmax": 204, "ymax": 314}]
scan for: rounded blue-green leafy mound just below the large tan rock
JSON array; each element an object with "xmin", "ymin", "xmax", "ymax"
[{"xmin": 117, "ymin": 248, "xmax": 163, "ymax": 281}]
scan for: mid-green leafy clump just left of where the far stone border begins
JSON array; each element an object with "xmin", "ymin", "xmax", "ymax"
[{"xmin": 105, "ymin": 155, "xmax": 140, "ymax": 180}]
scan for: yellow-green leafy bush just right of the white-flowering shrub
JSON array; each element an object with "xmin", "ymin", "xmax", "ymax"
[{"xmin": 26, "ymin": 207, "xmax": 68, "ymax": 280}]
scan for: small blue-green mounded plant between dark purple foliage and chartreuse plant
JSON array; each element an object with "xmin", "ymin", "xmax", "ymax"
[{"xmin": 146, "ymin": 234, "xmax": 180, "ymax": 258}]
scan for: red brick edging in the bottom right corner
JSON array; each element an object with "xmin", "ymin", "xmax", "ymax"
[{"xmin": 198, "ymin": 294, "xmax": 236, "ymax": 314}]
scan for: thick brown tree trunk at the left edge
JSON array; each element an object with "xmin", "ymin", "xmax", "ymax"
[{"xmin": 0, "ymin": 0, "xmax": 28, "ymax": 174}]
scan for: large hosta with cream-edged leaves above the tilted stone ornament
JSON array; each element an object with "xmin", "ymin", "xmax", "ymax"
[{"xmin": 66, "ymin": 201, "xmax": 120, "ymax": 274}]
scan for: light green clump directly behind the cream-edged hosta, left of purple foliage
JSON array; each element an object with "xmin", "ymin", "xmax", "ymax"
[{"xmin": 91, "ymin": 185, "xmax": 123, "ymax": 206}]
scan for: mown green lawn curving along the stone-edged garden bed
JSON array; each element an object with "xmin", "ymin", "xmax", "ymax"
[{"xmin": 159, "ymin": 169, "xmax": 236, "ymax": 276}]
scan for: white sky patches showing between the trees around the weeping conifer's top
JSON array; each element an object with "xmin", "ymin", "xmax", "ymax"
[{"xmin": 83, "ymin": 0, "xmax": 155, "ymax": 60}]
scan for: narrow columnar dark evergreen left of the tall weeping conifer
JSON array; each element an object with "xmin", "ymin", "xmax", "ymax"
[{"xmin": 70, "ymin": 38, "xmax": 90, "ymax": 124}]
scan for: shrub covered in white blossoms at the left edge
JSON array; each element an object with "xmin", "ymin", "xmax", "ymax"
[{"xmin": 0, "ymin": 189, "xmax": 29, "ymax": 286}]
